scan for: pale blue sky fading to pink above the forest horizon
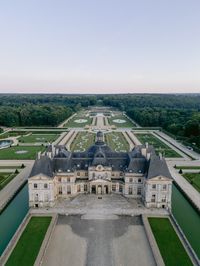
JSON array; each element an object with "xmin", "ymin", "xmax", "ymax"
[{"xmin": 0, "ymin": 0, "xmax": 200, "ymax": 93}]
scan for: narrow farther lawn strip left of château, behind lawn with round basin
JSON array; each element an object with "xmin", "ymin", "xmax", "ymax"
[{"xmin": 19, "ymin": 134, "xmax": 59, "ymax": 143}]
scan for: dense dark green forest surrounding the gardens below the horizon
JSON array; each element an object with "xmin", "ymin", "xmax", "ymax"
[{"xmin": 0, "ymin": 94, "xmax": 200, "ymax": 152}]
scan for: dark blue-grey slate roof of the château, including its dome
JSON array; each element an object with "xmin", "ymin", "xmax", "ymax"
[{"xmin": 30, "ymin": 132, "xmax": 171, "ymax": 179}]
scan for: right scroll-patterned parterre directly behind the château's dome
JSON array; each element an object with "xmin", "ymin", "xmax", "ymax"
[{"xmin": 105, "ymin": 132, "xmax": 130, "ymax": 152}]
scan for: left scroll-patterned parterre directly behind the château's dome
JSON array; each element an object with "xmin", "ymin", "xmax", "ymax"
[{"xmin": 70, "ymin": 132, "xmax": 96, "ymax": 152}]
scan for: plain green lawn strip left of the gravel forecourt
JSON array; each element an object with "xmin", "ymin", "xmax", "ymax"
[{"xmin": 6, "ymin": 217, "xmax": 52, "ymax": 266}]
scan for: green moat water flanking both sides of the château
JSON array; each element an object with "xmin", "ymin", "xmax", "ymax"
[{"xmin": 0, "ymin": 184, "xmax": 200, "ymax": 258}]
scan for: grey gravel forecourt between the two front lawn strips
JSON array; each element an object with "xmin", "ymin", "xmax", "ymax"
[{"xmin": 42, "ymin": 215, "xmax": 155, "ymax": 266}]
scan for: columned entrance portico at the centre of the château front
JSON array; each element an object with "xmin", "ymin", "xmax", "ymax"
[{"xmin": 89, "ymin": 179, "xmax": 111, "ymax": 195}]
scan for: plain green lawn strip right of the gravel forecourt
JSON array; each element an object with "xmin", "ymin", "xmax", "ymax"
[{"xmin": 148, "ymin": 217, "xmax": 193, "ymax": 266}]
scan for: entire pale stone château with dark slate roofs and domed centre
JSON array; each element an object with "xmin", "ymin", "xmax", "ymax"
[{"xmin": 28, "ymin": 131, "xmax": 172, "ymax": 209}]
